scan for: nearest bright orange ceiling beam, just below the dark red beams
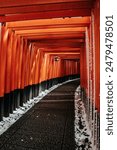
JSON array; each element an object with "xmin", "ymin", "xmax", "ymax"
[{"xmin": 6, "ymin": 17, "xmax": 91, "ymax": 30}]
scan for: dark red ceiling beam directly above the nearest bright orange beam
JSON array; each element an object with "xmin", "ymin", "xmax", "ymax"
[{"xmin": 0, "ymin": 9, "xmax": 91, "ymax": 22}]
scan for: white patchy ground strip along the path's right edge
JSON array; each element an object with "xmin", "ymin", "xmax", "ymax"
[{"xmin": 74, "ymin": 86, "xmax": 92, "ymax": 150}]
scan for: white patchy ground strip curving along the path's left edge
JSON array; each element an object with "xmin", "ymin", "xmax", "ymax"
[{"xmin": 0, "ymin": 79, "xmax": 77, "ymax": 135}]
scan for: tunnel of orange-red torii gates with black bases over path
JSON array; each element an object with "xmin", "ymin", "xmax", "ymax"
[{"xmin": 0, "ymin": 0, "xmax": 100, "ymax": 143}]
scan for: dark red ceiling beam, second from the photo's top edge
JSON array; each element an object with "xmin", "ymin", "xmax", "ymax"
[{"xmin": 0, "ymin": 1, "xmax": 92, "ymax": 15}]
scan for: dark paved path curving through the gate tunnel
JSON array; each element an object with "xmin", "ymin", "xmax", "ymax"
[{"xmin": 0, "ymin": 81, "xmax": 78, "ymax": 150}]
